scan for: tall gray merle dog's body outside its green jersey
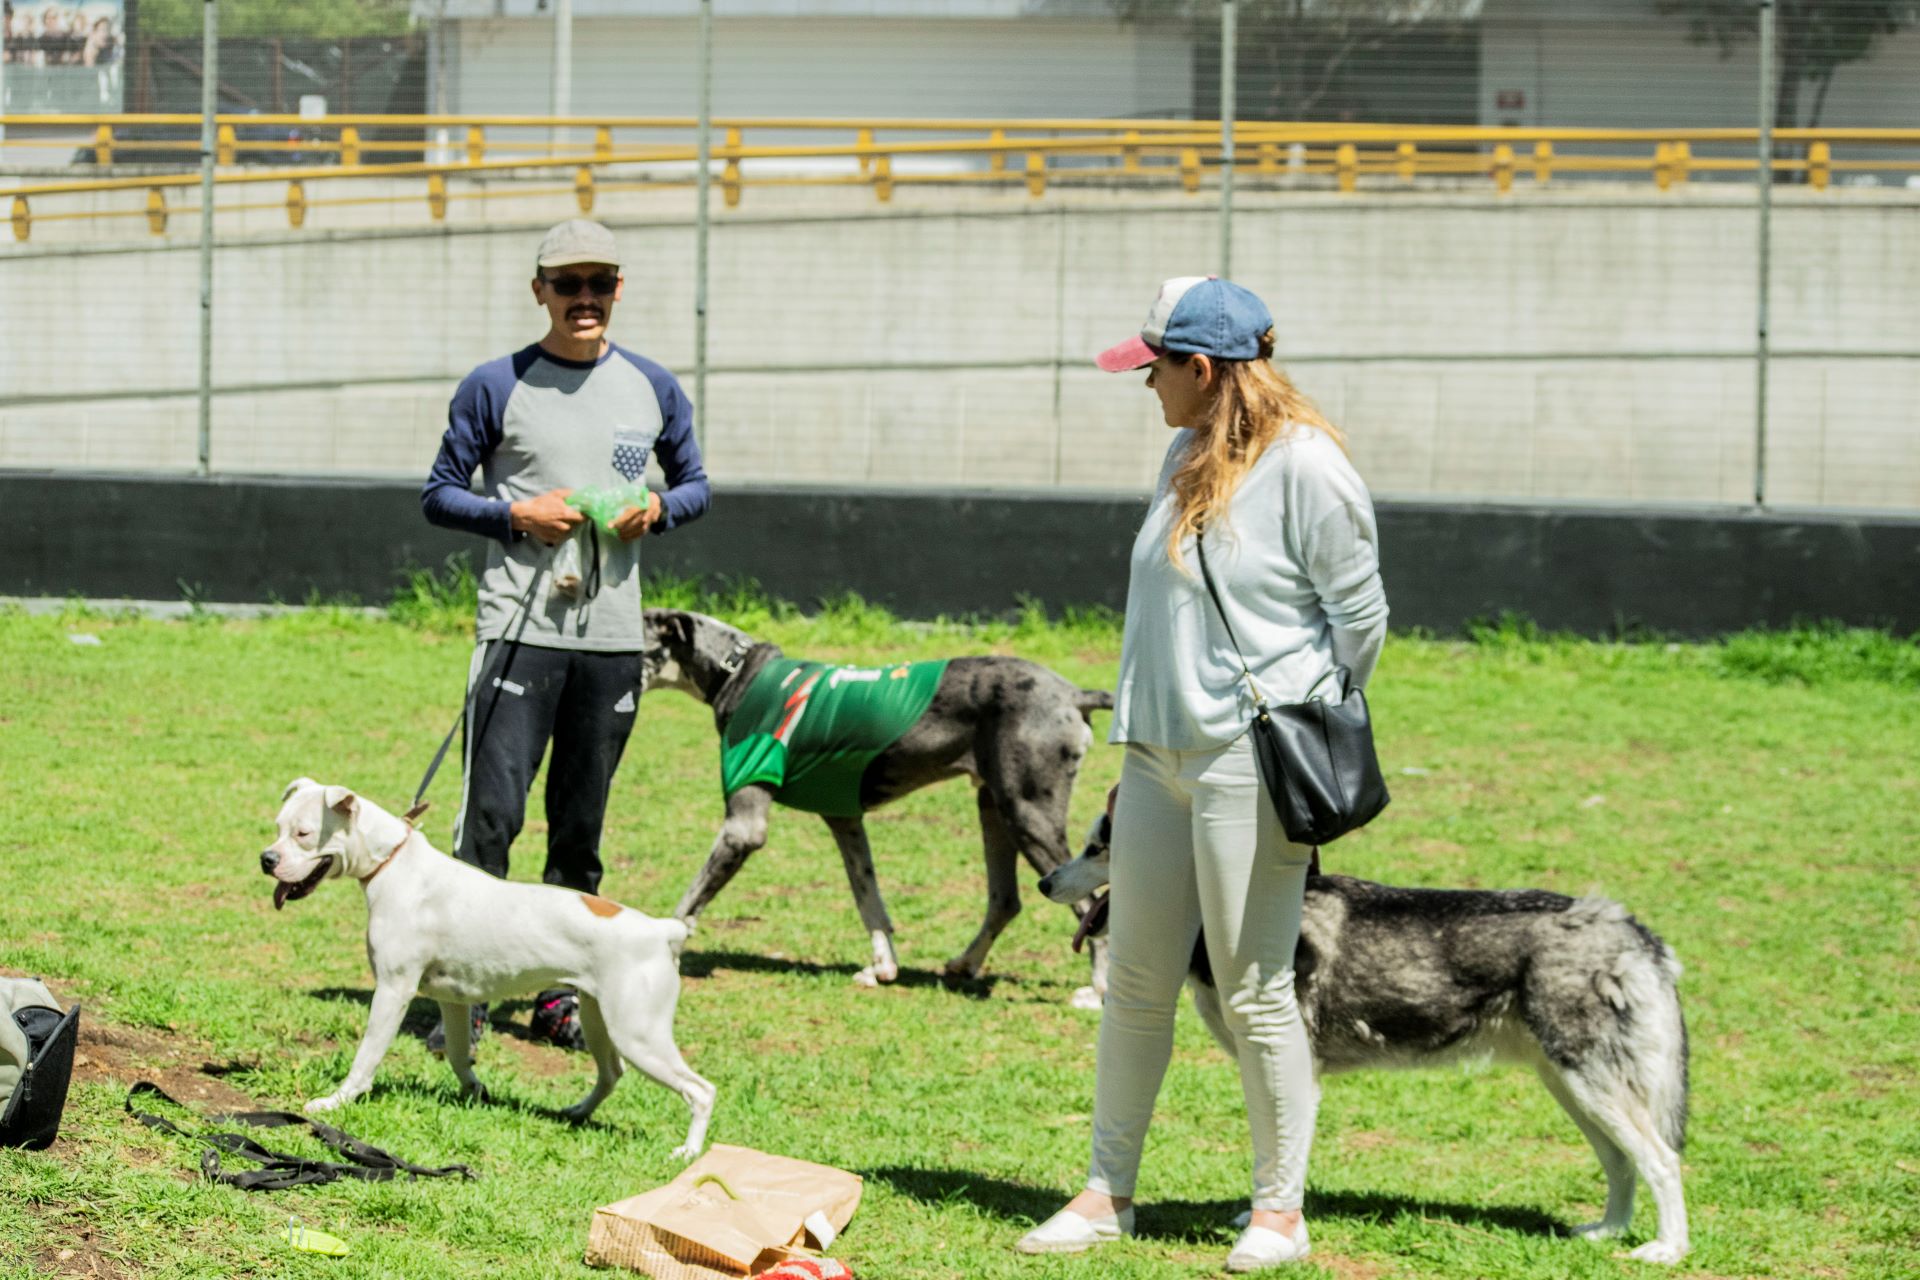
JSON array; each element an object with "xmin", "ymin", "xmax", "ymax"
[{"xmin": 641, "ymin": 608, "xmax": 1114, "ymax": 986}]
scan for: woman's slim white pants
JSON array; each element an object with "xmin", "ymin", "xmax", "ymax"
[{"xmin": 1087, "ymin": 735, "xmax": 1319, "ymax": 1209}]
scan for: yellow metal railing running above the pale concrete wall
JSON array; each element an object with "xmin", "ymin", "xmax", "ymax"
[{"xmin": 0, "ymin": 115, "xmax": 1920, "ymax": 240}]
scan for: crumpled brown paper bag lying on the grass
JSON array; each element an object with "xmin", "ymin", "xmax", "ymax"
[{"xmin": 586, "ymin": 1144, "xmax": 860, "ymax": 1280}]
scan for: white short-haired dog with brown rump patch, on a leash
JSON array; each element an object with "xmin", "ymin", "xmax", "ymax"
[{"xmin": 259, "ymin": 777, "xmax": 716, "ymax": 1159}]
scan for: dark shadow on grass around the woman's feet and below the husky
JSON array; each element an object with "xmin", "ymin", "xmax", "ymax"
[{"xmin": 858, "ymin": 1165, "xmax": 1571, "ymax": 1244}]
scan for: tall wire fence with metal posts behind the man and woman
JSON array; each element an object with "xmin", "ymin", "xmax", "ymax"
[{"xmin": 0, "ymin": 0, "xmax": 1920, "ymax": 510}]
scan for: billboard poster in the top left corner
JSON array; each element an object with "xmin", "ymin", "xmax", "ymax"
[{"xmin": 0, "ymin": 0, "xmax": 127, "ymax": 115}]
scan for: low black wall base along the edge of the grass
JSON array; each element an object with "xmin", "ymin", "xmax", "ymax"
[{"xmin": 0, "ymin": 472, "xmax": 1920, "ymax": 635}]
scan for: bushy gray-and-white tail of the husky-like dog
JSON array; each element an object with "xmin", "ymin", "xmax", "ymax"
[{"xmin": 1563, "ymin": 898, "xmax": 1688, "ymax": 1151}]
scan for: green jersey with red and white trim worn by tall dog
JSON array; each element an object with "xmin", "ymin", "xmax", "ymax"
[{"xmin": 720, "ymin": 658, "xmax": 947, "ymax": 818}]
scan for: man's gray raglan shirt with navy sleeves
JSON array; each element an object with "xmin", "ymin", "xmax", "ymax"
[{"xmin": 420, "ymin": 344, "xmax": 710, "ymax": 652}]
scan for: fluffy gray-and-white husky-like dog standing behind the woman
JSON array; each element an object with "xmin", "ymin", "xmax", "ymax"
[{"xmin": 1041, "ymin": 816, "xmax": 1688, "ymax": 1263}]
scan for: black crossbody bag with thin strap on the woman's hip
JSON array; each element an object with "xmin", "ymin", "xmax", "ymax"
[{"xmin": 1194, "ymin": 537, "xmax": 1388, "ymax": 846}]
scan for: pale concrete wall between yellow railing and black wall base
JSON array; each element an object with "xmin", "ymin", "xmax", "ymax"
[{"xmin": 0, "ymin": 184, "xmax": 1920, "ymax": 509}]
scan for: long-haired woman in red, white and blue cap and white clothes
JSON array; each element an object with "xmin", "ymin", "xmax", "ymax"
[{"xmin": 1020, "ymin": 276, "xmax": 1386, "ymax": 1272}]
